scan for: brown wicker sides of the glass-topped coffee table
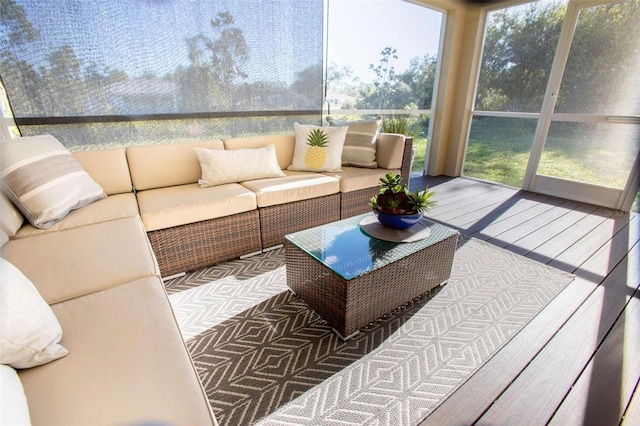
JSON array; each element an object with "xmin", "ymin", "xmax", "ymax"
[{"xmin": 285, "ymin": 234, "xmax": 458, "ymax": 338}]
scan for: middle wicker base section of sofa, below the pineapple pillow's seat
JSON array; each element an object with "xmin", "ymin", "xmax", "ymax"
[{"xmin": 258, "ymin": 193, "xmax": 340, "ymax": 248}]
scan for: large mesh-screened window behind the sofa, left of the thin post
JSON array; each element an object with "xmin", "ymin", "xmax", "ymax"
[{"xmin": 0, "ymin": 0, "xmax": 323, "ymax": 149}]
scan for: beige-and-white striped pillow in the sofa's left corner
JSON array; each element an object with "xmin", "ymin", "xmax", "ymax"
[{"xmin": 0, "ymin": 135, "xmax": 107, "ymax": 229}]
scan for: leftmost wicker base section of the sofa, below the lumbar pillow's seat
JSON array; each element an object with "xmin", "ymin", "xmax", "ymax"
[{"xmin": 147, "ymin": 210, "xmax": 262, "ymax": 277}]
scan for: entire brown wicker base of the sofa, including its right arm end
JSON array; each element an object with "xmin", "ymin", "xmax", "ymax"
[{"xmin": 147, "ymin": 138, "xmax": 413, "ymax": 277}]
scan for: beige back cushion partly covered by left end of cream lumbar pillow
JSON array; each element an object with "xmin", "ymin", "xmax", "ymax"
[{"xmin": 127, "ymin": 140, "xmax": 224, "ymax": 190}]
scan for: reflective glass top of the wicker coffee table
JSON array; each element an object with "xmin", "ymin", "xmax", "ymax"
[{"xmin": 285, "ymin": 213, "xmax": 458, "ymax": 280}]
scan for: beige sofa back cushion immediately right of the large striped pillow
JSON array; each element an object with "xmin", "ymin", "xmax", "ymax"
[{"xmin": 73, "ymin": 148, "xmax": 132, "ymax": 195}]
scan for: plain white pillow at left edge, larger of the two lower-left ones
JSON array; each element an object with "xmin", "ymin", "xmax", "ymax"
[{"xmin": 0, "ymin": 258, "xmax": 69, "ymax": 368}]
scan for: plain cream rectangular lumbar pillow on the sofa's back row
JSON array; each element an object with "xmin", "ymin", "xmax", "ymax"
[{"xmin": 195, "ymin": 145, "xmax": 286, "ymax": 188}]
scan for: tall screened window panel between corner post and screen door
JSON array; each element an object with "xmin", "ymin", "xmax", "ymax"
[{"xmin": 463, "ymin": 0, "xmax": 566, "ymax": 187}]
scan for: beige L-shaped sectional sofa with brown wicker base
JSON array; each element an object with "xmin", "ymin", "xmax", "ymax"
[{"xmin": 0, "ymin": 129, "xmax": 412, "ymax": 425}]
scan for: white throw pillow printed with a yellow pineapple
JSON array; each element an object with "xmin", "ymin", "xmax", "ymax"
[{"xmin": 288, "ymin": 123, "xmax": 348, "ymax": 172}]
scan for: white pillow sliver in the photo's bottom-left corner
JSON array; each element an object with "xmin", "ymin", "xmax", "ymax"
[{"xmin": 0, "ymin": 365, "xmax": 31, "ymax": 426}]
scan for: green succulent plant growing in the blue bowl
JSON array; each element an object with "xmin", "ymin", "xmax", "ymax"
[{"xmin": 369, "ymin": 172, "xmax": 435, "ymax": 214}]
